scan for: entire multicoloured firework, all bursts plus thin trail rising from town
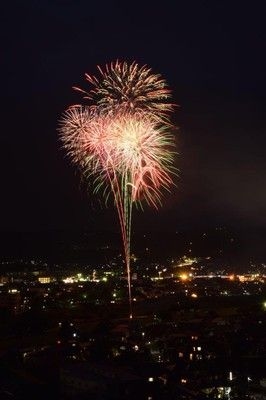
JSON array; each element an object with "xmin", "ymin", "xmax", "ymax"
[{"xmin": 59, "ymin": 63, "xmax": 175, "ymax": 318}]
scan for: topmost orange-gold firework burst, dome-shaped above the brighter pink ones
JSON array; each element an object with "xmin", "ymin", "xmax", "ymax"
[{"xmin": 74, "ymin": 61, "xmax": 174, "ymax": 121}]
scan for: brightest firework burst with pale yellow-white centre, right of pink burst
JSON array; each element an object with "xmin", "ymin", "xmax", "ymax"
[{"xmin": 106, "ymin": 112, "xmax": 177, "ymax": 207}]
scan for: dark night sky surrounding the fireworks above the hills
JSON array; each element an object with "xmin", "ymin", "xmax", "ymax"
[{"xmin": 0, "ymin": 0, "xmax": 266, "ymax": 232}]
